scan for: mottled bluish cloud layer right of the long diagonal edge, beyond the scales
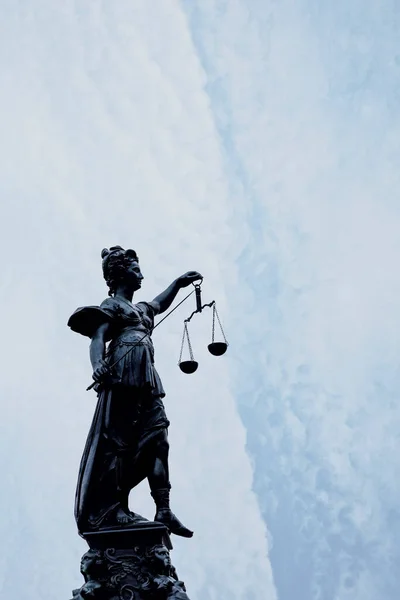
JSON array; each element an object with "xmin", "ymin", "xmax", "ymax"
[{"xmin": 184, "ymin": 1, "xmax": 400, "ymax": 600}]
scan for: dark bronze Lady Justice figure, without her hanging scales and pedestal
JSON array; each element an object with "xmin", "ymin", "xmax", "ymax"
[{"xmin": 68, "ymin": 246, "xmax": 202, "ymax": 537}]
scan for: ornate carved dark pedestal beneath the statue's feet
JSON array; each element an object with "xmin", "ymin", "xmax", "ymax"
[{"xmin": 72, "ymin": 521, "xmax": 189, "ymax": 600}]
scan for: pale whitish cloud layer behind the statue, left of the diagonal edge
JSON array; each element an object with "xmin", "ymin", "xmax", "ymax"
[{"xmin": 0, "ymin": 0, "xmax": 275, "ymax": 600}]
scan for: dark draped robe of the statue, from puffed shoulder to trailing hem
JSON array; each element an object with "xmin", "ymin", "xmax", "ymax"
[{"xmin": 68, "ymin": 298, "xmax": 169, "ymax": 533}]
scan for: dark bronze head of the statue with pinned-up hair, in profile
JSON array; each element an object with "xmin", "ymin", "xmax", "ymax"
[{"xmin": 101, "ymin": 246, "xmax": 143, "ymax": 296}]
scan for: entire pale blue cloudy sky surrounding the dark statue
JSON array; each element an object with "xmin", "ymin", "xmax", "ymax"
[{"xmin": 0, "ymin": 0, "xmax": 400, "ymax": 600}]
